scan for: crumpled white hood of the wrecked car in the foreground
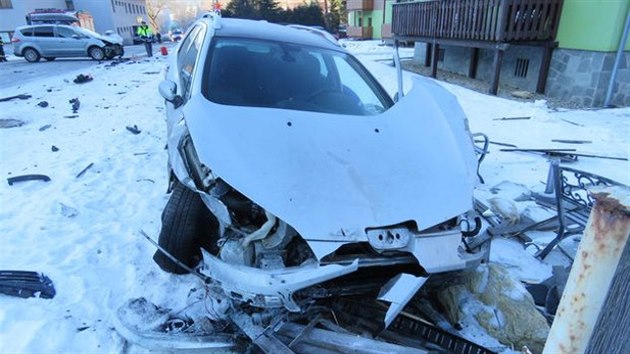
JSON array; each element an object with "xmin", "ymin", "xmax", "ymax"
[{"xmin": 184, "ymin": 78, "xmax": 477, "ymax": 242}]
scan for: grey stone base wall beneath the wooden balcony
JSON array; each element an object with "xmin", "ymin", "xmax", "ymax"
[{"xmin": 414, "ymin": 42, "xmax": 630, "ymax": 107}]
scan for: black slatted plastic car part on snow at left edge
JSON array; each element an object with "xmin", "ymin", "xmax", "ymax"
[{"xmin": 0, "ymin": 270, "xmax": 56, "ymax": 299}]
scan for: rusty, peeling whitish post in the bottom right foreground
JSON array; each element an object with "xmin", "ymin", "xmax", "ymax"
[{"xmin": 543, "ymin": 186, "xmax": 630, "ymax": 354}]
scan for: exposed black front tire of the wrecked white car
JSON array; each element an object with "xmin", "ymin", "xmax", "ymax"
[{"xmin": 153, "ymin": 181, "xmax": 218, "ymax": 274}]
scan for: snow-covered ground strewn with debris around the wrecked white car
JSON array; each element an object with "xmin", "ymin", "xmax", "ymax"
[{"xmin": 0, "ymin": 41, "xmax": 630, "ymax": 353}]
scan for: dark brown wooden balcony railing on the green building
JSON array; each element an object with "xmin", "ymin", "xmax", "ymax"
[{"xmin": 392, "ymin": 0, "xmax": 563, "ymax": 42}]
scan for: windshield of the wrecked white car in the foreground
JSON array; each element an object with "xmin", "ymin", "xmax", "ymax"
[{"xmin": 202, "ymin": 37, "xmax": 393, "ymax": 115}]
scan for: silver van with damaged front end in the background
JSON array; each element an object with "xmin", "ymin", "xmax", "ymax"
[{"xmin": 11, "ymin": 24, "xmax": 124, "ymax": 63}]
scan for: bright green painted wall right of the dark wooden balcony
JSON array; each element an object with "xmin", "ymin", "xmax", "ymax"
[{"xmin": 556, "ymin": 0, "xmax": 630, "ymax": 52}]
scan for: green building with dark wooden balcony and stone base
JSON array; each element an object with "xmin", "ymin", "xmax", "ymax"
[{"xmin": 348, "ymin": 0, "xmax": 630, "ymax": 107}]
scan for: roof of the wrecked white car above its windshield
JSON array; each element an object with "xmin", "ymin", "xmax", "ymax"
[{"xmin": 203, "ymin": 18, "xmax": 345, "ymax": 52}]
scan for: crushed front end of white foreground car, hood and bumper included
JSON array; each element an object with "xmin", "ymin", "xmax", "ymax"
[{"xmin": 162, "ymin": 75, "xmax": 488, "ymax": 324}]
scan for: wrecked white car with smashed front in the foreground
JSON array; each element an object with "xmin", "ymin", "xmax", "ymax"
[{"xmin": 121, "ymin": 16, "xmax": 489, "ymax": 352}]
